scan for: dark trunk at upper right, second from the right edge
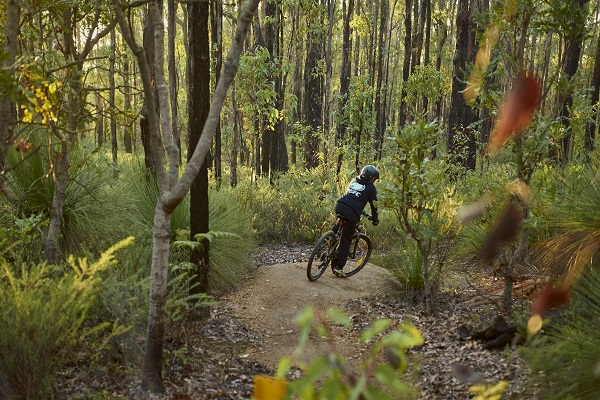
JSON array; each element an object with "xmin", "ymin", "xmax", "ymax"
[{"xmin": 558, "ymin": 0, "xmax": 588, "ymax": 162}]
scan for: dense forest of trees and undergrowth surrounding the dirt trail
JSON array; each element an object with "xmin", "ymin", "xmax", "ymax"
[{"xmin": 0, "ymin": 0, "xmax": 600, "ymax": 398}]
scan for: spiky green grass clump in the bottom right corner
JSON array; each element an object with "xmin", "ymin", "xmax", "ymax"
[{"xmin": 523, "ymin": 264, "xmax": 600, "ymax": 400}]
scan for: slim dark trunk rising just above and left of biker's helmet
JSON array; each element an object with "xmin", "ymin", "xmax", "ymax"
[{"xmin": 335, "ymin": 0, "xmax": 354, "ymax": 177}]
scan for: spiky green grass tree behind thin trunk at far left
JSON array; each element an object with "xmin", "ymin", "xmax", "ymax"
[{"xmin": 2, "ymin": 135, "xmax": 127, "ymax": 260}]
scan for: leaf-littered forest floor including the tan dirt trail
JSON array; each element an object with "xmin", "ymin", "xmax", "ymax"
[{"xmin": 54, "ymin": 244, "xmax": 537, "ymax": 400}]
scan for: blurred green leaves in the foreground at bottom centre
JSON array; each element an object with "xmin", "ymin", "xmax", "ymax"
[{"xmin": 277, "ymin": 307, "xmax": 423, "ymax": 399}]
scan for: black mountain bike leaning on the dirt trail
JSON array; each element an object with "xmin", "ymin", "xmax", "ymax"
[{"xmin": 306, "ymin": 211, "xmax": 373, "ymax": 281}]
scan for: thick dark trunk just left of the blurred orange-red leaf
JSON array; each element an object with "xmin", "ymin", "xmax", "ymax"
[{"xmin": 446, "ymin": 0, "xmax": 477, "ymax": 170}]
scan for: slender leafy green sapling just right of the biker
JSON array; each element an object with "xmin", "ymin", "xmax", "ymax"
[{"xmin": 385, "ymin": 120, "xmax": 448, "ymax": 312}]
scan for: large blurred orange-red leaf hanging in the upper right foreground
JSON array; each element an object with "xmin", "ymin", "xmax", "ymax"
[{"xmin": 489, "ymin": 72, "xmax": 542, "ymax": 152}]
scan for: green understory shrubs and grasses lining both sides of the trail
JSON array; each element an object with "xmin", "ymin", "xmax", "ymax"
[{"xmin": 0, "ymin": 128, "xmax": 600, "ymax": 399}]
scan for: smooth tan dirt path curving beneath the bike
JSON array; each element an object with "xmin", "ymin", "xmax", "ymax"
[{"xmin": 223, "ymin": 262, "xmax": 390, "ymax": 369}]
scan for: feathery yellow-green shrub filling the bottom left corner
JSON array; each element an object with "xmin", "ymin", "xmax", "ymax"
[{"xmin": 0, "ymin": 238, "xmax": 133, "ymax": 399}]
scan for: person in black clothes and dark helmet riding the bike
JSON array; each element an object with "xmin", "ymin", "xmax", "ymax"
[{"xmin": 331, "ymin": 165, "xmax": 379, "ymax": 278}]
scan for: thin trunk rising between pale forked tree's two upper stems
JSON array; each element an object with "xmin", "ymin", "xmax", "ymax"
[{"xmin": 167, "ymin": 0, "xmax": 181, "ymax": 162}]
